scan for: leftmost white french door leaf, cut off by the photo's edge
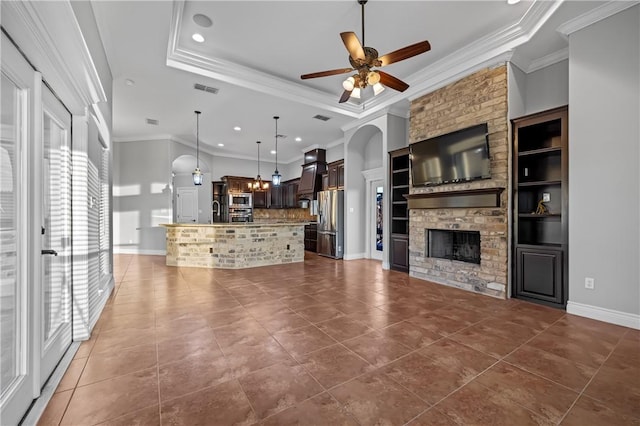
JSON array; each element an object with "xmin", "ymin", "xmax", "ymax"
[{"xmin": 0, "ymin": 34, "xmax": 39, "ymax": 425}]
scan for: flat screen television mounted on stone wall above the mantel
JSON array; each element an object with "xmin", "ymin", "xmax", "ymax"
[{"xmin": 409, "ymin": 123, "xmax": 491, "ymax": 186}]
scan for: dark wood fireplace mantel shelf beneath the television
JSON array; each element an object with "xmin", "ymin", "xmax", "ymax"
[{"xmin": 405, "ymin": 188, "xmax": 504, "ymax": 209}]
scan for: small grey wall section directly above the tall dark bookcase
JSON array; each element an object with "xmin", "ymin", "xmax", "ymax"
[{"xmin": 524, "ymin": 60, "xmax": 569, "ymax": 115}]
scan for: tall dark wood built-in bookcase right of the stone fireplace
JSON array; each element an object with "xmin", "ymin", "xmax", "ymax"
[{"xmin": 512, "ymin": 107, "xmax": 569, "ymax": 308}]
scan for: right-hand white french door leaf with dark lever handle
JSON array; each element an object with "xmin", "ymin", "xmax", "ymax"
[{"xmin": 40, "ymin": 81, "xmax": 73, "ymax": 386}]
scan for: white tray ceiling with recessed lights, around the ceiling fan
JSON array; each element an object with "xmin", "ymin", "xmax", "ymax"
[{"xmin": 92, "ymin": 0, "xmax": 602, "ymax": 163}]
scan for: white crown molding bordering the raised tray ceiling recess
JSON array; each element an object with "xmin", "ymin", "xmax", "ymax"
[{"xmin": 167, "ymin": 0, "xmax": 564, "ymax": 125}]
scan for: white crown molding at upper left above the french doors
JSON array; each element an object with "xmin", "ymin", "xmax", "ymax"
[{"xmin": 2, "ymin": 1, "xmax": 107, "ymax": 115}]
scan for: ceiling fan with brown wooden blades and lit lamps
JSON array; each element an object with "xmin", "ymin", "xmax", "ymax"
[{"xmin": 300, "ymin": 0, "xmax": 431, "ymax": 103}]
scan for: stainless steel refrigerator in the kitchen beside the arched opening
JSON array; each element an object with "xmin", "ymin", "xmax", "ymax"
[{"xmin": 318, "ymin": 190, "xmax": 344, "ymax": 259}]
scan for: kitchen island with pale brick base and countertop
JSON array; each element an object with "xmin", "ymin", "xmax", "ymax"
[{"xmin": 162, "ymin": 222, "xmax": 307, "ymax": 269}]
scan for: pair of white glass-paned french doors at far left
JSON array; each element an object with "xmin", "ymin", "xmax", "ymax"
[{"xmin": 0, "ymin": 34, "xmax": 71, "ymax": 426}]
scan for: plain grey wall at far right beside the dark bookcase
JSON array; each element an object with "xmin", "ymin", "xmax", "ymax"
[{"xmin": 567, "ymin": 5, "xmax": 640, "ymax": 328}]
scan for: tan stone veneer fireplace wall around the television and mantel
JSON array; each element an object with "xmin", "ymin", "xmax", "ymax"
[{"xmin": 409, "ymin": 65, "xmax": 509, "ymax": 298}]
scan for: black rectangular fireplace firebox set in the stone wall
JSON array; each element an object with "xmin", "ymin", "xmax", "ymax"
[{"xmin": 425, "ymin": 229, "xmax": 480, "ymax": 265}]
